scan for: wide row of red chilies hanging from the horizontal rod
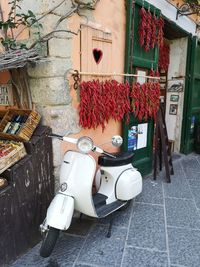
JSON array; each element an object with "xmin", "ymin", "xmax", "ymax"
[{"xmin": 79, "ymin": 78, "xmax": 160, "ymax": 130}]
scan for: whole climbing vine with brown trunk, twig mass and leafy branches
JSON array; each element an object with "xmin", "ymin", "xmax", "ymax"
[{"xmin": 0, "ymin": 0, "xmax": 99, "ymax": 109}]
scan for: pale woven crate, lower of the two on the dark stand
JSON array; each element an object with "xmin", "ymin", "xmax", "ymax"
[{"xmin": 0, "ymin": 141, "xmax": 26, "ymax": 174}]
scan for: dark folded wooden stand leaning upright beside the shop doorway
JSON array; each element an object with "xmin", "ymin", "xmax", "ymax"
[{"xmin": 154, "ymin": 107, "xmax": 174, "ymax": 183}]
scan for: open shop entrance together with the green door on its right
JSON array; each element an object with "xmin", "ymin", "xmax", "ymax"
[{"xmin": 161, "ymin": 20, "xmax": 200, "ymax": 154}]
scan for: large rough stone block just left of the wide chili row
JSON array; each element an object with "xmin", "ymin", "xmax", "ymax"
[{"xmin": 30, "ymin": 77, "xmax": 71, "ymax": 106}]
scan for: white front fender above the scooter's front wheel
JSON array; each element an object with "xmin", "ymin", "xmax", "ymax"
[{"xmin": 46, "ymin": 193, "xmax": 74, "ymax": 230}]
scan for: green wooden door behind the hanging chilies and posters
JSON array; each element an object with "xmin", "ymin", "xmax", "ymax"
[{"xmin": 123, "ymin": 0, "xmax": 160, "ymax": 175}]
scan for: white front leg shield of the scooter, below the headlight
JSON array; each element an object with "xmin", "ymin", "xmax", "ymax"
[{"xmin": 60, "ymin": 151, "xmax": 97, "ymax": 217}]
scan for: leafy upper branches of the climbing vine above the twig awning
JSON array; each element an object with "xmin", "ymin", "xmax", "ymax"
[{"xmin": 0, "ymin": 0, "xmax": 99, "ymax": 50}]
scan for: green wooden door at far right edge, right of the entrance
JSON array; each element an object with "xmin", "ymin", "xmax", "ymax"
[{"xmin": 181, "ymin": 37, "xmax": 200, "ymax": 154}]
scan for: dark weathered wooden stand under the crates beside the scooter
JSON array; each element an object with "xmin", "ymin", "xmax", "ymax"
[{"xmin": 0, "ymin": 125, "xmax": 54, "ymax": 266}]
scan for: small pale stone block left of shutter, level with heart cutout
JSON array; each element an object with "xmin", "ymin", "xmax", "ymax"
[{"xmin": 48, "ymin": 38, "xmax": 72, "ymax": 58}]
